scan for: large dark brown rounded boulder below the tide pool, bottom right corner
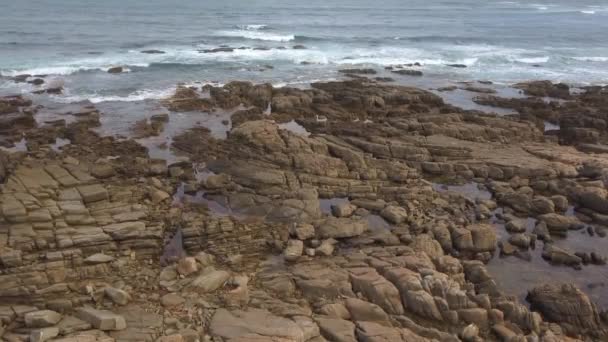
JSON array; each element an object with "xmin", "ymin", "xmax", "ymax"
[{"xmin": 526, "ymin": 284, "xmax": 600, "ymax": 329}]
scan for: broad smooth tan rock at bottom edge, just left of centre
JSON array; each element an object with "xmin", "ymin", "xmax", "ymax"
[{"xmin": 209, "ymin": 309, "xmax": 304, "ymax": 342}]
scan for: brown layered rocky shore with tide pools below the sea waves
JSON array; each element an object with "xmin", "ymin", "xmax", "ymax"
[{"xmin": 0, "ymin": 78, "xmax": 608, "ymax": 342}]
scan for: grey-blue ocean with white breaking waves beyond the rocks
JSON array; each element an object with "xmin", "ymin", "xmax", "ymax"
[{"xmin": 0, "ymin": 0, "xmax": 608, "ymax": 103}]
